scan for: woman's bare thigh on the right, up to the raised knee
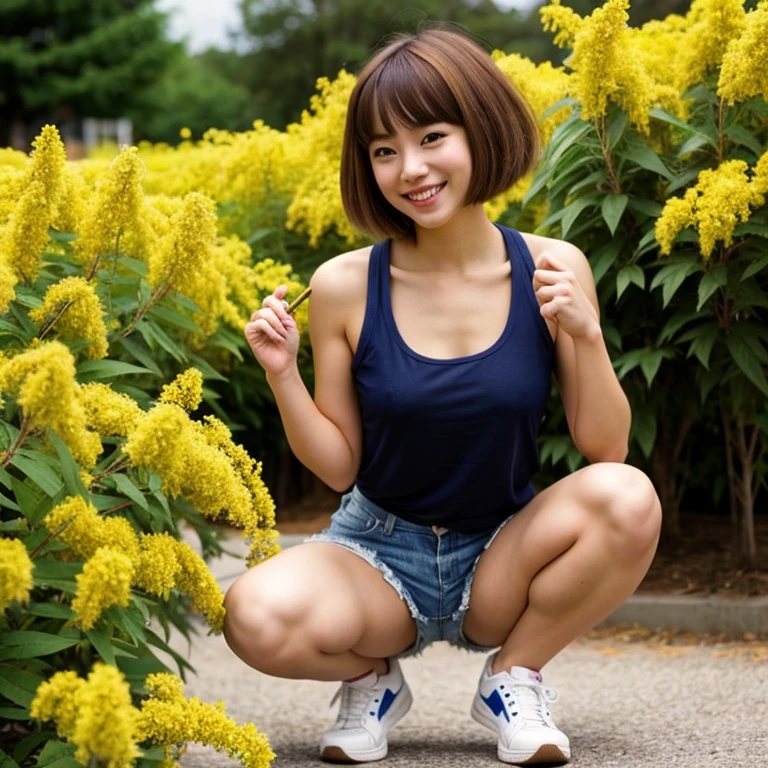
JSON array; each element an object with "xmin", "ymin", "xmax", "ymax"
[{"xmin": 463, "ymin": 463, "xmax": 658, "ymax": 645}]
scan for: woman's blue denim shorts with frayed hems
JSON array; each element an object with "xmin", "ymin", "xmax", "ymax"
[{"xmin": 305, "ymin": 487, "xmax": 513, "ymax": 658}]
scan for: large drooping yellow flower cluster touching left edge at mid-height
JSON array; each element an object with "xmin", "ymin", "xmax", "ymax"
[{"xmin": 0, "ymin": 341, "xmax": 102, "ymax": 468}]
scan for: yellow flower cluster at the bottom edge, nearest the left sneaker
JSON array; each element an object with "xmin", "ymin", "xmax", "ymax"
[{"xmin": 139, "ymin": 674, "xmax": 275, "ymax": 768}]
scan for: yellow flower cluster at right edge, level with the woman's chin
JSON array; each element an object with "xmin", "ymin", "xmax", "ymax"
[{"xmin": 656, "ymin": 152, "xmax": 768, "ymax": 259}]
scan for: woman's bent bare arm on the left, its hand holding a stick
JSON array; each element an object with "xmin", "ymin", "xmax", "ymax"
[{"xmin": 246, "ymin": 259, "xmax": 362, "ymax": 492}]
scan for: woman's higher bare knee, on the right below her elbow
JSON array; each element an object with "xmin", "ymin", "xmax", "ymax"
[{"xmin": 589, "ymin": 463, "xmax": 661, "ymax": 559}]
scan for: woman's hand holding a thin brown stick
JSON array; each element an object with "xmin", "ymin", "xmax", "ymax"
[{"xmin": 245, "ymin": 285, "xmax": 299, "ymax": 376}]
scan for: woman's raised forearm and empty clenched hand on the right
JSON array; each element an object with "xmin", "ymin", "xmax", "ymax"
[{"xmin": 534, "ymin": 241, "xmax": 632, "ymax": 462}]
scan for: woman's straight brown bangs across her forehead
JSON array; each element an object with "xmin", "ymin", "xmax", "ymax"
[{"xmin": 357, "ymin": 48, "xmax": 464, "ymax": 147}]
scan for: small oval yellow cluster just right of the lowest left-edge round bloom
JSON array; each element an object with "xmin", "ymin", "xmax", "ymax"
[{"xmin": 72, "ymin": 541, "xmax": 133, "ymax": 630}]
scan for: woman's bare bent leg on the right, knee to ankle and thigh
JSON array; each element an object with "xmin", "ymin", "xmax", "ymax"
[{"xmin": 464, "ymin": 464, "xmax": 661, "ymax": 673}]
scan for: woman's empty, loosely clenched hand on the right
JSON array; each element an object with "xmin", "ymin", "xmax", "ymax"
[{"xmin": 533, "ymin": 251, "xmax": 600, "ymax": 339}]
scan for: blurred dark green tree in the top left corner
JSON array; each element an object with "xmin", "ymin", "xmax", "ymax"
[{"xmin": 0, "ymin": 0, "xmax": 181, "ymax": 146}]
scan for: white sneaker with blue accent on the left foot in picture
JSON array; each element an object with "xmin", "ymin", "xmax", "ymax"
[{"xmin": 320, "ymin": 659, "xmax": 413, "ymax": 763}]
